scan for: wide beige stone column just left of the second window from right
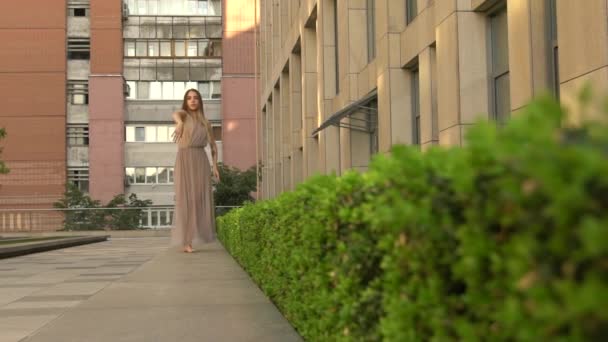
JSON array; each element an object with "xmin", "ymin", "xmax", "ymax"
[{"xmin": 435, "ymin": 1, "xmax": 489, "ymax": 146}]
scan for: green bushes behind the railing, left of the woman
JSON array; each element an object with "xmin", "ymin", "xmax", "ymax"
[{"xmin": 53, "ymin": 183, "xmax": 152, "ymax": 230}]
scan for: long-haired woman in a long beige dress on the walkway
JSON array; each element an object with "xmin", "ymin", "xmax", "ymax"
[{"xmin": 172, "ymin": 89, "xmax": 219, "ymax": 253}]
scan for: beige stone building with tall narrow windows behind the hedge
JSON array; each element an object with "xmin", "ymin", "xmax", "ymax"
[{"xmin": 258, "ymin": 0, "xmax": 608, "ymax": 198}]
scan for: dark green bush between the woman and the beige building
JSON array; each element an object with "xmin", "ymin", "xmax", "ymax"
[{"xmin": 213, "ymin": 163, "xmax": 257, "ymax": 215}]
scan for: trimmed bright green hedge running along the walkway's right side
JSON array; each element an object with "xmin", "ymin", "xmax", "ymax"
[{"xmin": 218, "ymin": 99, "xmax": 608, "ymax": 341}]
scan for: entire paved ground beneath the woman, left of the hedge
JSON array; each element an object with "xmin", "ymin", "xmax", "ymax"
[{"xmin": 0, "ymin": 238, "xmax": 301, "ymax": 342}]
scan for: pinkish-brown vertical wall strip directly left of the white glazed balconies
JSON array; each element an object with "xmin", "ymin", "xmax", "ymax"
[{"xmin": 89, "ymin": 0, "xmax": 125, "ymax": 203}]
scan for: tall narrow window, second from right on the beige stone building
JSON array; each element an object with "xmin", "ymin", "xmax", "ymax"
[{"xmin": 490, "ymin": 6, "xmax": 511, "ymax": 124}]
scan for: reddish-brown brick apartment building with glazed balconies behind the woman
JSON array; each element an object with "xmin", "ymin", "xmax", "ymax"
[{"xmin": 0, "ymin": 0, "xmax": 257, "ymax": 232}]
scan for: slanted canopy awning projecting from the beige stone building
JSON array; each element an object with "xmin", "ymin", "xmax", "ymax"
[{"xmin": 312, "ymin": 89, "xmax": 378, "ymax": 137}]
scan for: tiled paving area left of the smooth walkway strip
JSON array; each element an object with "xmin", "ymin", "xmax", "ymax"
[{"xmin": 0, "ymin": 238, "xmax": 168, "ymax": 342}]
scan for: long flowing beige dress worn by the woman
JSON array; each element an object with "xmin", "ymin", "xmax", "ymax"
[{"xmin": 171, "ymin": 115, "xmax": 215, "ymax": 246}]
